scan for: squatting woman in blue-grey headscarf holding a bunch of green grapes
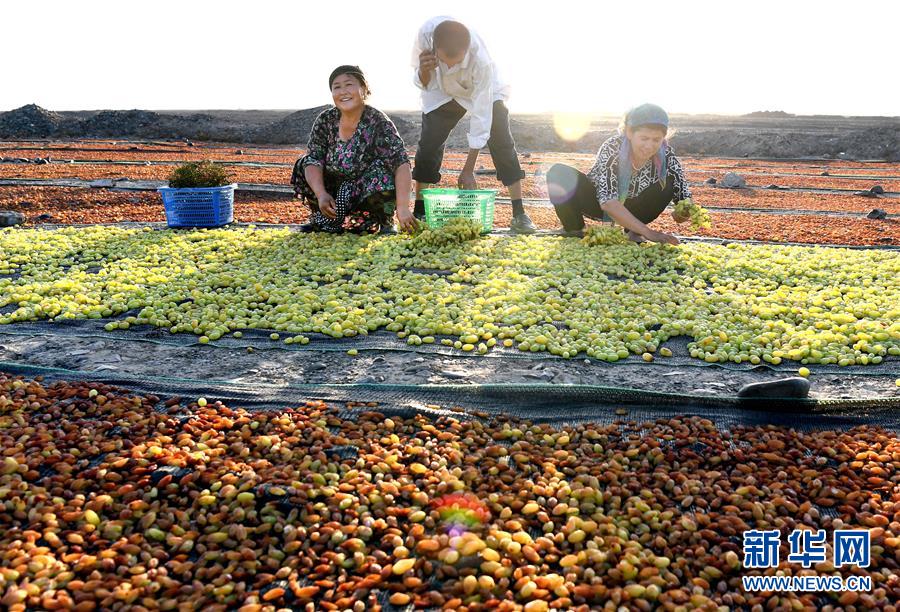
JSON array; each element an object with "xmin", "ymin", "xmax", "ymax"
[{"xmin": 547, "ymin": 104, "xmax": 691, "ymax": 244}]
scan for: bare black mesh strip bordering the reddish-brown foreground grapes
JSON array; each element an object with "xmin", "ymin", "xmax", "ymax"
[{"xmin": 0, "ymin": 362, "xmax": 900, "ymax": 431}]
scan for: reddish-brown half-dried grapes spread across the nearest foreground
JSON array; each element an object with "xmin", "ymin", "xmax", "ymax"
[{"xmin": 0, "ymin": 372, "xmax": 900, "ymax": 612}]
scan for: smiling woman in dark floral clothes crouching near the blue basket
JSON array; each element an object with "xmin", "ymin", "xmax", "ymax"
[{"xmin": 291, "ymin": 66, "xmax": 416, "ymax": 233}]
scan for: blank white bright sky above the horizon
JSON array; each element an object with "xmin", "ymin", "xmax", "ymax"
[{"xmin": 0, "ymin": 0, "xmax": 900, "ymax": 116}]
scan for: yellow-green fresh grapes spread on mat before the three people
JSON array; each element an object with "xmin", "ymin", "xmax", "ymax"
[{"xmin": 0, "ymin": 226, "xmax": 900, "ymax": 365}]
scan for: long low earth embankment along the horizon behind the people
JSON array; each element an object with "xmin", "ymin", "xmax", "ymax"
[{"xmin": 0, "ymin": 104, "xmax": 900, "ymax": 161}]
